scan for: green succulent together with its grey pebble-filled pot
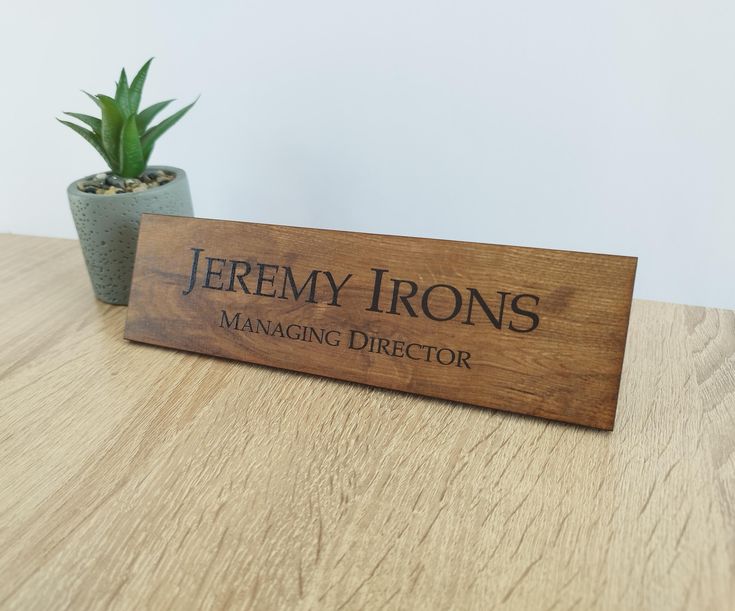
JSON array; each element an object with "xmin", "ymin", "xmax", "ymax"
[{"xmin": 59, "ymin": 59, "xmax": 196, "ymax": 304}]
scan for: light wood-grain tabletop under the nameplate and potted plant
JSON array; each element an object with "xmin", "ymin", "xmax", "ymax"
[{"xmin": 0, "ymin": 235, "xmax": 735, "ymax": 610}]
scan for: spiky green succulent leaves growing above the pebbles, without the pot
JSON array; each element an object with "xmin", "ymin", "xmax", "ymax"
[{"xmin": 58, "ymin": 58, "xmax": 196, "ymax": 178}]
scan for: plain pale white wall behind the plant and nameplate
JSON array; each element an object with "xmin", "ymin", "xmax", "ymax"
[{"xmin": 0, "ymin": 0, "xmax": 735, "ymax": 308}]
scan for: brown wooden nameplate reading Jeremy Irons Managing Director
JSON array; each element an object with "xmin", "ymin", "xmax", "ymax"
[{"xmin": 125, "ymin": 215, "xmax": 636, "ymax": 429}]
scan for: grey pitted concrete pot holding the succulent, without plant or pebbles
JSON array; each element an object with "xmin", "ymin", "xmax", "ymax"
[{"xmin": 67, "ymin": 166, "xmax": 194, "ymax": 305}]
